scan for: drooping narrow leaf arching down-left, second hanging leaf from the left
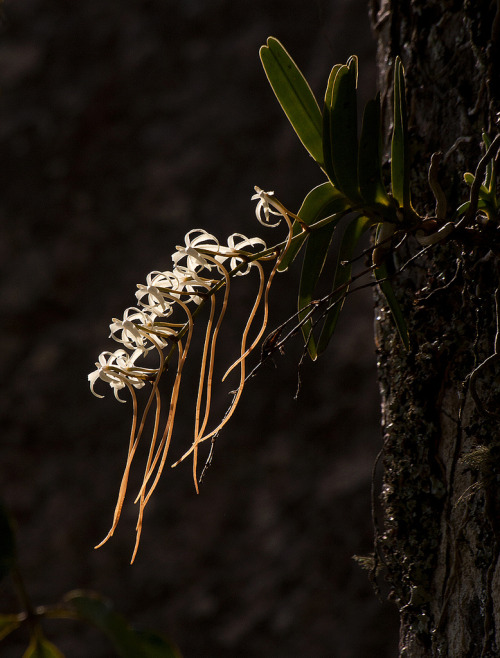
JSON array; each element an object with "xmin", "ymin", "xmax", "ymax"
[{"xmin": 317, "ymin": 216, "xmax": 373, "ymax": 354}]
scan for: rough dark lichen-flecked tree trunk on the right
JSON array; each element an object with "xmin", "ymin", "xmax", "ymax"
[{"xmin": 371, "ymin": 0, "xmax": 500, "ymax": 658}]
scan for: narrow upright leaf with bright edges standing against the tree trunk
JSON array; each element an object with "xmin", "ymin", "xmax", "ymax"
[{"xmin": 391, "ymin": 57, "xmax": 410, "ymax": 210}]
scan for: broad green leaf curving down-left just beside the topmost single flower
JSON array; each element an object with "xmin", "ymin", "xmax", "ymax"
[{"xmin": 278, "ymin": 183, "xmax": 348, "ymax": 272}]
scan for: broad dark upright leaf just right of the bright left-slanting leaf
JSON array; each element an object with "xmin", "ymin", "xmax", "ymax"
[{"xmin": 323, "ymin": 57, "xmax": 360, "ymax": 202}]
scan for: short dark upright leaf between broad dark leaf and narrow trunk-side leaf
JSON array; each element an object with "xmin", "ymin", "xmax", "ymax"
[{"xmin": 358, "ymin": 94, "xmax": 392, "ymax": 208}]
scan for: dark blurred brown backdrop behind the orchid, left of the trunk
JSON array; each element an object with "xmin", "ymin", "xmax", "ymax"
[{"xmin": 0, "ymin": 0, "xmax": 397, "ymax": 658}]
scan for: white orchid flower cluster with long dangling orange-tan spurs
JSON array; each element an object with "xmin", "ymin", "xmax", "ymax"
[{"xmin": 88, "ymin": 187, "xmax": 293, "ymax": 562}]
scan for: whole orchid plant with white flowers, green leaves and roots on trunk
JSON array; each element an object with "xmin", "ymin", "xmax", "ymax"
[{"xmin": 89, "ymin": 37, "xmax": 500, "ymax": 561}]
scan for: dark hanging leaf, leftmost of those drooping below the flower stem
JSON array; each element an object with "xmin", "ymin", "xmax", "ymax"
[{"xmin": 298, "ymin": 222, "xmax": 337, "ymax": 361}]
